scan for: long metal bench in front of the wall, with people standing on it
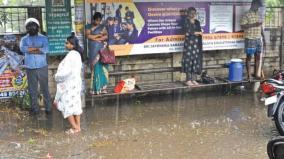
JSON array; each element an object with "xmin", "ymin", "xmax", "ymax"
[{"xmin": 86, "ymin": 65, "xmax": 253, "ymax": 100}]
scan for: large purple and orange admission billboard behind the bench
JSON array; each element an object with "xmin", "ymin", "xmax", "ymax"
[{"xmin": 85, "ymin": 0, "xmax": 251, "ymax": 56}]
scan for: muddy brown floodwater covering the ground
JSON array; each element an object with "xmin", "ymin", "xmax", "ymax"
[{"xmin": 0, "ymin": 88, "xmax": 278, "ymax": 159}]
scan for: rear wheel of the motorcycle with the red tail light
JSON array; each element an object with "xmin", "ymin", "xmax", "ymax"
[{"xmin": 274, "ymin": 102, "xmax": 284, "ymax": 136}]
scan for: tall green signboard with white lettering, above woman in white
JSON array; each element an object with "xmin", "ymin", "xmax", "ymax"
[{"xmin": 45, "ymin": 0, "xmax": 72, "ymax": 55}]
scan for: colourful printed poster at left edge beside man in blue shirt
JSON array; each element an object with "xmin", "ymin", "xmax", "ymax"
[{"xmin": 0, "ymin": 68, "xmax": 28, "ymax": 99}]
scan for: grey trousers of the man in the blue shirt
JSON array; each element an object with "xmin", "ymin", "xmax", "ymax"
[{"xmin": 27, "ymin": 66, "xmax": 51, "ymax": 111}]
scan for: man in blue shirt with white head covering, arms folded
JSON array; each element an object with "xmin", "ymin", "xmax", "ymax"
[{"xmin": 20, "ymin": 18, "xmax": 51, "ymax": 115}]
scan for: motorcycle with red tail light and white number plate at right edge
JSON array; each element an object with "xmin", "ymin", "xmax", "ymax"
[{"xmin": 260, "ymin": 71, "xmax": 284, "ymax": 135}]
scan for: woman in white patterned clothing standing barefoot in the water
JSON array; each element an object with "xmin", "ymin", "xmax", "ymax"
[{"xmin": 54, "ymin": 36, "xmax": 83, "ymax": 134}]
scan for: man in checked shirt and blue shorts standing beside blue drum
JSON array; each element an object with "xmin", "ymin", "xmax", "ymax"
[{"xmin": 241, "ymin": 0, "xmax": 265, "ymax": 81}]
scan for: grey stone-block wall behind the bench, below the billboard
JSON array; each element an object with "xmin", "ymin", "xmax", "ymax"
[{"xmin": 49, "ymin": 28, "xmax": 281, "ymax": 94}]
